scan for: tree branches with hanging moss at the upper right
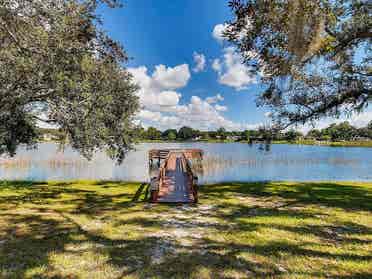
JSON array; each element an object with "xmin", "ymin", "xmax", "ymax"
[{"xmin": 224, "ymin": 0, "xmax": 372, "ymax": 128}]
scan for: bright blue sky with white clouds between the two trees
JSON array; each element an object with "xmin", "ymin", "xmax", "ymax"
[{"xmin": 99, "ymin": 0, "xmax": 372, "ymax": 130}]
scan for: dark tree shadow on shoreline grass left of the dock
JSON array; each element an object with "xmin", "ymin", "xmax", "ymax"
[{"xmin": 0, "ymin": 181, "xmax": 145, "ymax": 212}]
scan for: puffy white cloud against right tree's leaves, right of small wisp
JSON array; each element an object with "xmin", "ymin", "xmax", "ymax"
[{"xmin": 212, "ymin": 47, "xmax": 257, "ymax": 91}]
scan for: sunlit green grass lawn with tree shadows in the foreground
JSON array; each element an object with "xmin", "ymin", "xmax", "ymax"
[{"xmin": 0, "ymin": 181, "xmax": 372, "ymax": 279}]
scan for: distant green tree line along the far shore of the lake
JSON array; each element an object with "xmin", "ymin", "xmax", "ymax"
[{"xmin": 132, "ymin": 121, "xmax": 372, "ymax": 142}]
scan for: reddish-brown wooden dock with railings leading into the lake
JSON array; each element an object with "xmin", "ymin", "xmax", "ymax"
[{"xmin": 149, "ymin": 149, "xmax": 202, "ymax": 203}]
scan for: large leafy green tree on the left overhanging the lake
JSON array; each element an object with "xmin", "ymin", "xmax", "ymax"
[{"xmin": 0, "ymin": 0, "xmax": 139, "ymax": 163}]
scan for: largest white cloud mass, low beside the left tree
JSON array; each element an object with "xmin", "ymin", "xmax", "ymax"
[{"xmin": 129, "ymin": 64, "xmax": 258, "ymax": 130}]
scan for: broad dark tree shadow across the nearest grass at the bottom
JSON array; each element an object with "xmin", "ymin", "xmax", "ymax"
[{"xmin": 0, "ymin": 211, "xmax": 372, "ymax": 278}]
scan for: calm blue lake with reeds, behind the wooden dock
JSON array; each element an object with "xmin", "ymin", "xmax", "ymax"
[{"xmin": 0, "ymin": 143, "xmax": 372, "ymax": 183}]
